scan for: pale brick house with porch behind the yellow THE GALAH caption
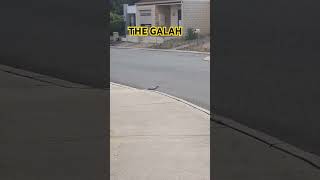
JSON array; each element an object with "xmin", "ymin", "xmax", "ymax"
[{"xmin": 124, "ymin": 0, "xmax": 210, "ymax": 42}]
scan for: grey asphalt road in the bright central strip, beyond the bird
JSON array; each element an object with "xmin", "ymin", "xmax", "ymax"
[{"xmin": 110, "ymin": 48, "xmax": 210, "ymax": 110}]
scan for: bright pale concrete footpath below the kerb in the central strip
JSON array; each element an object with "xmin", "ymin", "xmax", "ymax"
[{"xmin": 110, "ymin": 83, "xmax": 210, "ymax": 180}]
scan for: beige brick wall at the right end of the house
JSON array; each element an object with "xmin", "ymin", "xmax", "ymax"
[{"xmin": 182, "ymin": 0, "xmax": 210, "ymax": 35}]
